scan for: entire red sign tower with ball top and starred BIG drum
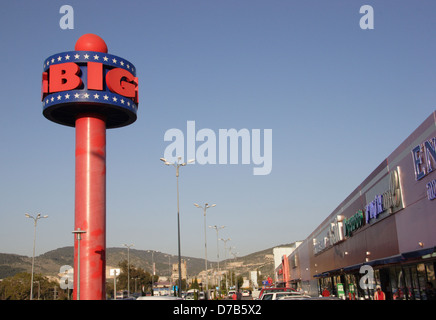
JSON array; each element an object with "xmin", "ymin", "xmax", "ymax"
[{"xmin": 42, "ymin": 34, "xmax": 138, "ymax": 300}]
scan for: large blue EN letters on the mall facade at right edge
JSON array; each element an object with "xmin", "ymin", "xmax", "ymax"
[{"xmin": 412, "ymin": 137, "xmax": 436, "ymax": 180}]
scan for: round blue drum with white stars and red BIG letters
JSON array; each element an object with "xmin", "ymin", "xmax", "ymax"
[{"xmin": 41, "ymin": 51, "xmax": 138, "ymax": 128}]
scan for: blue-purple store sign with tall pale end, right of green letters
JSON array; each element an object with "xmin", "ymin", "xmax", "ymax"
[{"xmin": 365, "ymin": 168, "xmax": 402, "ymax": 223}]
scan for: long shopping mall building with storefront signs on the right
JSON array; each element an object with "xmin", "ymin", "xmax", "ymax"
[{"xmin": 276, "ymin": 112, "xmax": 436, "ymax": 300}]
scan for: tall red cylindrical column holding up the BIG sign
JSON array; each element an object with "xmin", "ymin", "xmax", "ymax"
[{"xmin": 74, "ymin": 114, "xmax": 106, "ymax": 300}]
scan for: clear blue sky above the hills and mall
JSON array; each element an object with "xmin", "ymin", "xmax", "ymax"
[{"xmin": 0, "ymin": 0, "xmax": 436, "ymax": 260}]
